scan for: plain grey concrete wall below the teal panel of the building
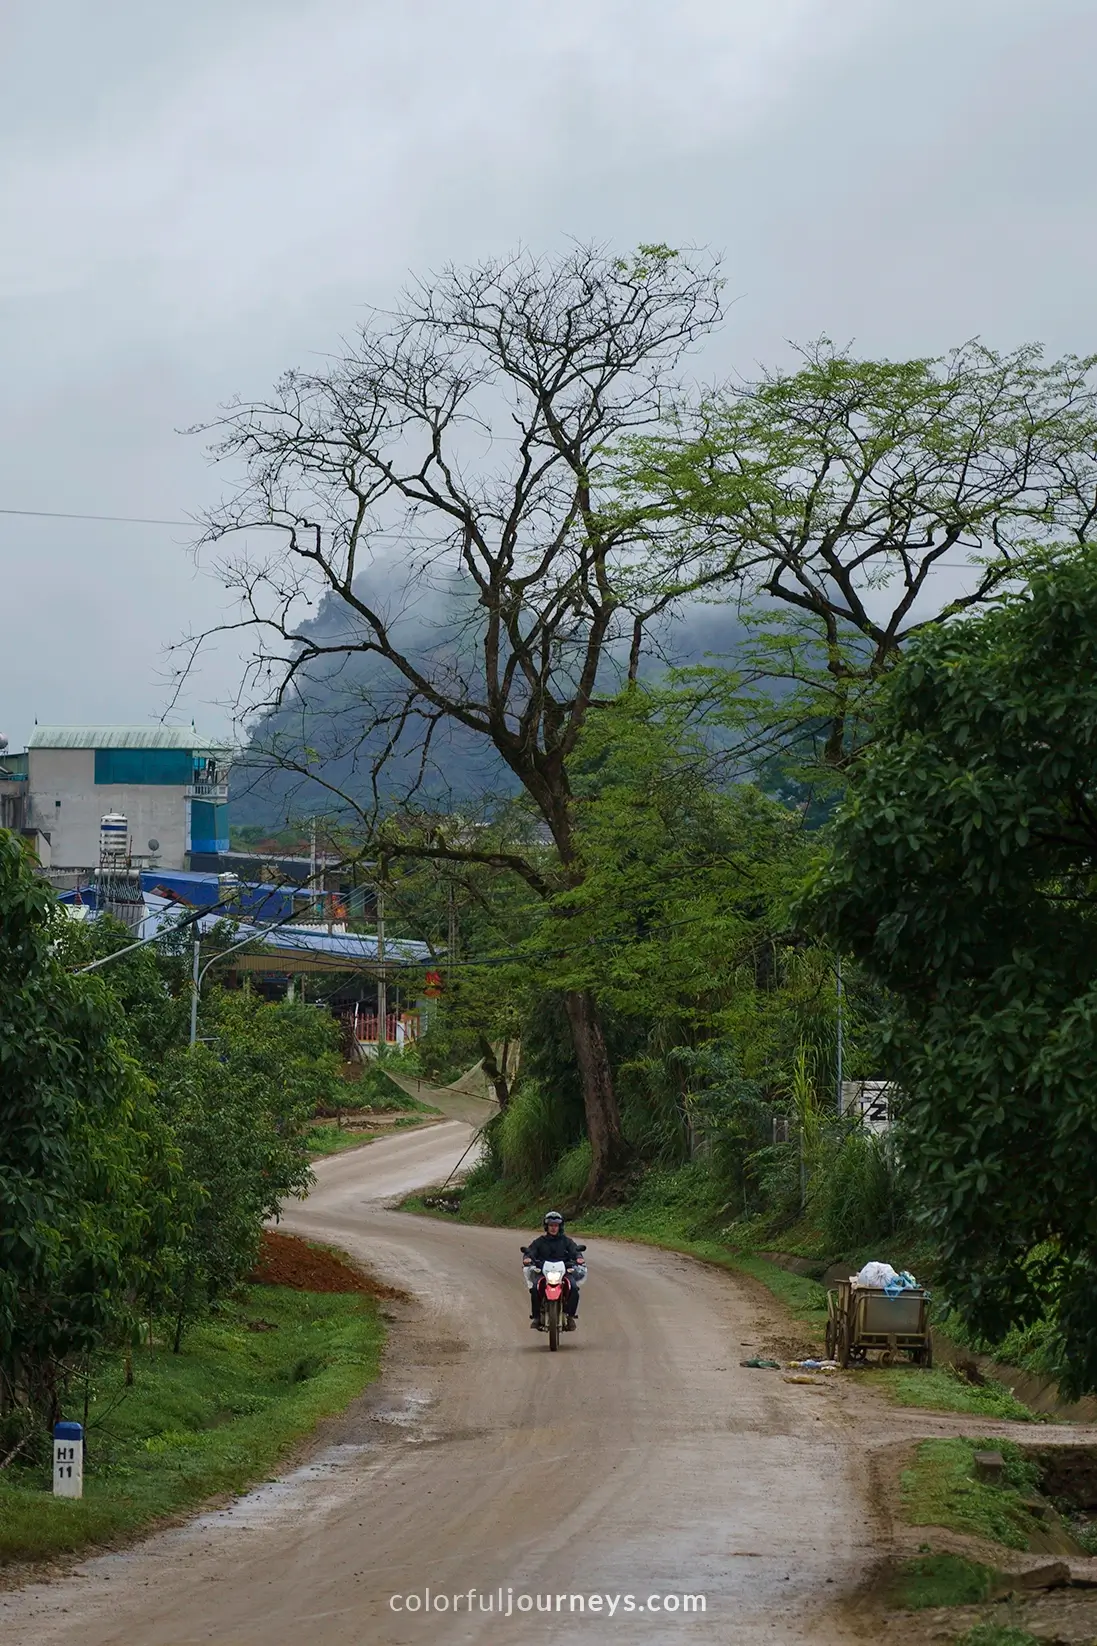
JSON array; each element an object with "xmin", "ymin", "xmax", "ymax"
[{"xmin": 28, "ymin": 749, "xmax": 186, "ymax": 869}]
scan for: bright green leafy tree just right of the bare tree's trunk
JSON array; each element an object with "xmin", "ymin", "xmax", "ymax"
[{"xmin": 524, "ymin": 688, "xmax": 875, "ymax": 1208}]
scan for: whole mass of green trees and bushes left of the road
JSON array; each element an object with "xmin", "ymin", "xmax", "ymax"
[{"xmin": 0, "ymin": 831, "xmax": 362, "ymax": 1422}]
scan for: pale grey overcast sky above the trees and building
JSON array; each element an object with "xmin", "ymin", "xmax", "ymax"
[{"xmin": 0, "ymin": 0, "xmax": 1097, "ymax": 747}]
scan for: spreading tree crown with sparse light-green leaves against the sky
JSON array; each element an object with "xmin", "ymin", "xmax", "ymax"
[{"xmin": 623, "ymin": 337, "xmax": 1097, "ymax": 779}]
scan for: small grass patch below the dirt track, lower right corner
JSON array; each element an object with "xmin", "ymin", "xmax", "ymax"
[{"xmin": 901, "ymin": 1439, "xmax": 1072, "ymax": 1553}]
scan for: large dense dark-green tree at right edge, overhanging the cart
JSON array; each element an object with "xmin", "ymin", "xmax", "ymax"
[{"xmin": 812, "ymin": 546, "xmax": 1097, "ymax": 1393}]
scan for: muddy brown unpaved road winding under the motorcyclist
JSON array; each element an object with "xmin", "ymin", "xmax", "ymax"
[{"xmin": 0, "ymin": 1121, "xmax": 878, "ymax": 1646}]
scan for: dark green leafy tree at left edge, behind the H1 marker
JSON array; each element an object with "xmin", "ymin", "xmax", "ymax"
[{"xmin": 0, "ymin": 830, "xmax": 178, "ymax": 1420}]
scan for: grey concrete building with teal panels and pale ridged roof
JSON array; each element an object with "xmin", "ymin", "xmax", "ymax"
[{"xmin": 20, "ymin": 726, "xmax": 231, "ymax": 876}]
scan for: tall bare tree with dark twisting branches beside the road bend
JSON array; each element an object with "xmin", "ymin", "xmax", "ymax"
[{"xmin": 180, "ymin": 247, "xmax": 720, "ymax": 1197}]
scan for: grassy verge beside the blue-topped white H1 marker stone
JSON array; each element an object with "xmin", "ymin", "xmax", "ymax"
[{"xmin": 0, "ymin": 1286, "xmax": 384, "ymax": 1564}]
